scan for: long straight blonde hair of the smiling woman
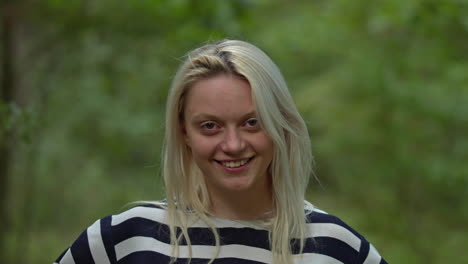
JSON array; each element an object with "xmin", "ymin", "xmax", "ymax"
[{"xmin": 163, "ymin": 40, "xmax": 312, "ymax": 264}]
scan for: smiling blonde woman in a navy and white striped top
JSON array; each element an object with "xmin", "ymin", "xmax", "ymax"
[{"xmin": 57, "ymin": 40, "xmax": 386, "ymax": 264}]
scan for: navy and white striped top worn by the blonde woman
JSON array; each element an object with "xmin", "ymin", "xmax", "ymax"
[{"xmin": 55, "ymin": 205, "xmax": 386, "ymax": 264}]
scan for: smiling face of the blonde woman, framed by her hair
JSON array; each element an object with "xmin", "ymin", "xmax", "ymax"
[{"xmin": 183, "ymin": 75, "xmax": 273, "ymax": 198}]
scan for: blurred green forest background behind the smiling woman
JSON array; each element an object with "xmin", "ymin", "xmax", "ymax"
[{"xmin": 0, "ymin": 0, "xmax": 468, "ymax": 263}]
